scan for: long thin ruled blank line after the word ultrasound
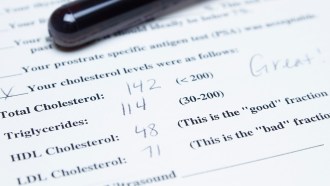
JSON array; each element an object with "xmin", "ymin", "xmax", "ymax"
[{"xmin": 182, "ymin": 144, "xmax": 324, "ymax": 178}]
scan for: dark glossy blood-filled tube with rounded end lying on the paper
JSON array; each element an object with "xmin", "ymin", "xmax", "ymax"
[{"xmin": 48, "ymin": 0, "xmax": 166, "ymax": 48}]
